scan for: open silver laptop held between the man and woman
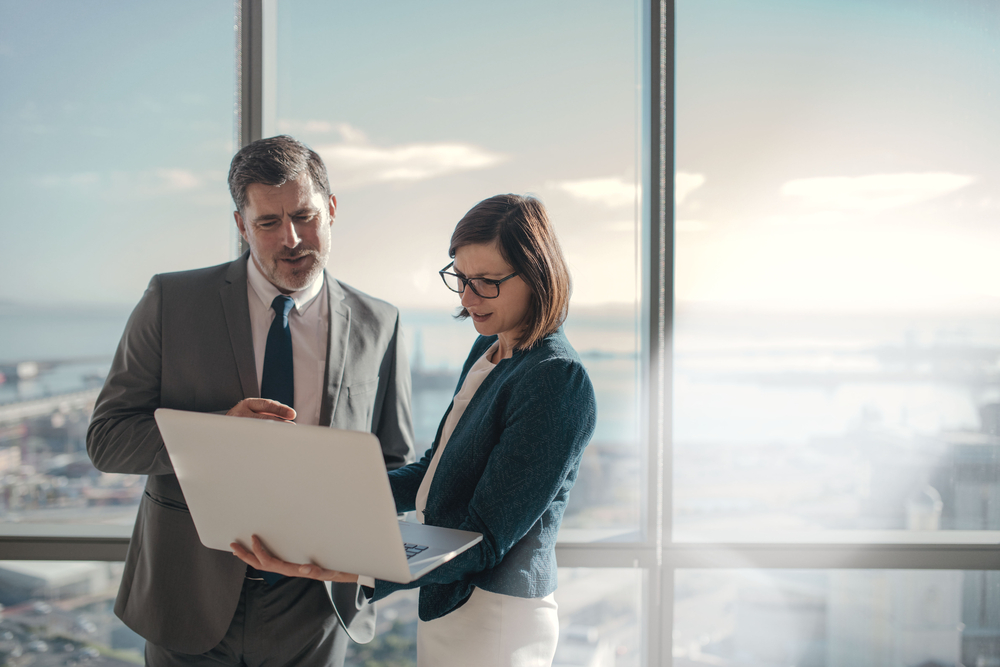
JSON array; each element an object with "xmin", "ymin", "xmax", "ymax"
[{"xmin": 154, "ymin": 408, "xmax": 483, "ymax": 583}]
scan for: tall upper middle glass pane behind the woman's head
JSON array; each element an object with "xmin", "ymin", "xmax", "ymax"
[{"xmin": 277, "ymin": 0, "xmax": 645, "ymax": 540}]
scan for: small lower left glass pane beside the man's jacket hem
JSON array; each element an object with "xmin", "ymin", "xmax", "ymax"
[{"xmin": 0, "ymin": 561, "xmax": 145, "ymax": 667}]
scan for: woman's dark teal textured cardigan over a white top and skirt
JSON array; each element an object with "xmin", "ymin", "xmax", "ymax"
[{"xmin": 366, "ymin": 329, "xmax": 597, "ymax": 621}]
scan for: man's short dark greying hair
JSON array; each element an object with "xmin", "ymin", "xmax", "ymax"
[{"xmin": 229, "ymin": 134, "xmax": 333, "ymax": 214}]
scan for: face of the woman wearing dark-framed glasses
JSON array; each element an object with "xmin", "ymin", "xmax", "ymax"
[{"xmin": 452, "ymin": 243, "xmax": 531, "ymax": 346}]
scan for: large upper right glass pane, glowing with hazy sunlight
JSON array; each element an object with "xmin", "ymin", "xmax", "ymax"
[{"xmin": 673, "ymin": 0, "xmax": 1000, "ymax": 542}]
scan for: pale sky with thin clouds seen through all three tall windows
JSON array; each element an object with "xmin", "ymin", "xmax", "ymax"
[{"xmin": 0, "ymin": 0, "xmax": 1000, "ymax": 310}]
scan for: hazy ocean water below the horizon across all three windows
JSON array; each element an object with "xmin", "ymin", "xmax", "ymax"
[{"xmin": 0, "ymin": 304, "xmax": 1000, "ymax": 446}]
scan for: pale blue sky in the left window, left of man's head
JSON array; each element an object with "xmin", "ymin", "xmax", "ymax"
[{"xmin": 0, "ymin": 1, "xmax": 235, "ymax": 303}]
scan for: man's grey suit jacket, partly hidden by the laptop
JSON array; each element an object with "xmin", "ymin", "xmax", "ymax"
[{"xmin": 87, "ymin": 255, "xmax": 413, "ymax": 653}]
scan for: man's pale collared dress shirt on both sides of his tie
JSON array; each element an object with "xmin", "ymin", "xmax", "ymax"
[{"xmin": 247, "ymin": 257, "xmax": 330, "ymax": 426}]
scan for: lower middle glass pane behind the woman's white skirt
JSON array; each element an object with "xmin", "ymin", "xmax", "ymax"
[{"xmin": 347, "ymin": 568, "xmax": 643, "ymax": 667}]
